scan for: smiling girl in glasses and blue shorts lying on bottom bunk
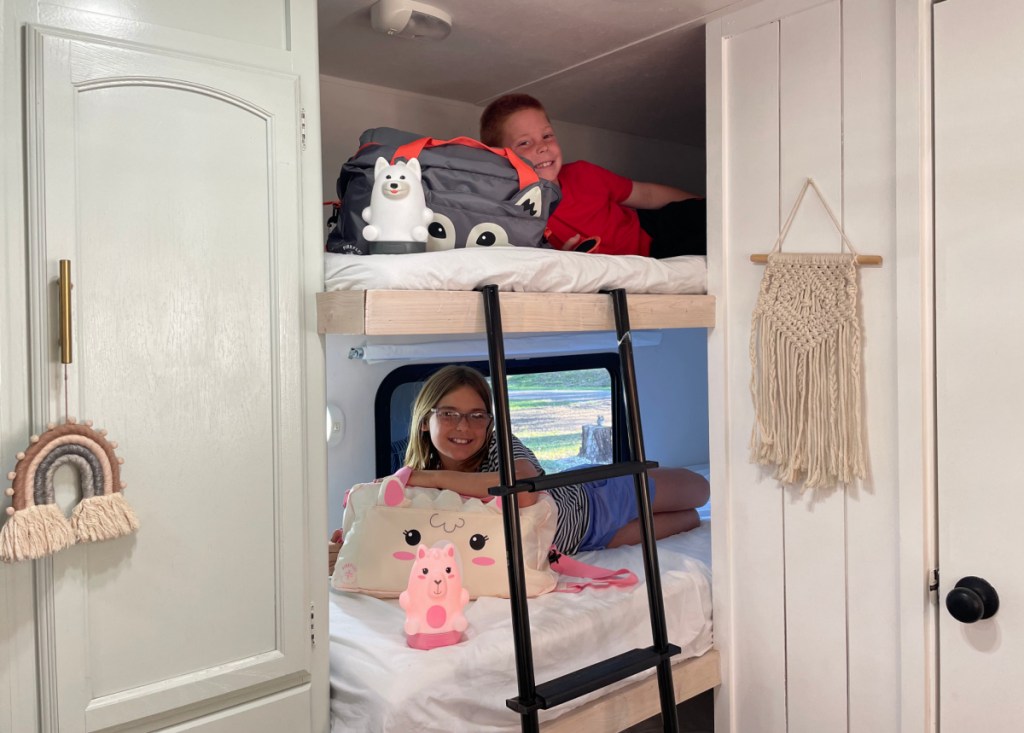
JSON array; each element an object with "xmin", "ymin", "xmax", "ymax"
[{"xmin": 406, "ymin": 365, "xmax": 710, "ymax": 555}]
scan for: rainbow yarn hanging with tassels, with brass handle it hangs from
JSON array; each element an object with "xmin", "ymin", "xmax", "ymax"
[{"xmin": 0, "ymin": 260, "xmax": 138, "ymax": 562}]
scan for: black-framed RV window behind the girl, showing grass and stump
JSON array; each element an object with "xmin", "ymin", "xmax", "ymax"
[{"xmin": 375, "ymin": 354, "xmax": 626, "ymax": 476}]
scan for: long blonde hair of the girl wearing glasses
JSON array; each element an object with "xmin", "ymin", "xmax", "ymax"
[{"xmin": 406, "ymin": 364, "xmax": 494, "ymax": 471}]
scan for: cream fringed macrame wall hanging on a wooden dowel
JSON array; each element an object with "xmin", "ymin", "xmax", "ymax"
[{"xmin": 751, "ymin": 178, "xmax": 881, "ymax": 488}]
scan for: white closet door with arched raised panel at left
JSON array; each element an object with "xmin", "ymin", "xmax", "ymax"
[{"xmin": 26, "ymin": 28, "xmax": 315, "ymax": 733}]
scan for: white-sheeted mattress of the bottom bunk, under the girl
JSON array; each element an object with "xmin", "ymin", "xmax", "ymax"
[{"xmin": 330, "ymin": 523, "xmax": 712, "ymax": 733}]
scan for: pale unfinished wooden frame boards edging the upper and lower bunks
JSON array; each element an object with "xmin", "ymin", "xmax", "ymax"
[{"xmin": 316, "ymin": 290, "xmax": 722, "ymax": 733}]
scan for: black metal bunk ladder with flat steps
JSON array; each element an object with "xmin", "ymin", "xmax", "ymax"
[{"xmin": 479, "ymin": 285, "xmax": 681, "ymax": 733}]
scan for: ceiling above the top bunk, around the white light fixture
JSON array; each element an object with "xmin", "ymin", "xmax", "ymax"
[{"xmin": 318, "ymin": 0, "xmax": 745, "ymax": 147}]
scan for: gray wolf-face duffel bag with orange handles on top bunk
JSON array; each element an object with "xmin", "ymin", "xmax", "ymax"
[{"xmin": 327, "ymin": 127, "xmax": 561, "ymax": 255}]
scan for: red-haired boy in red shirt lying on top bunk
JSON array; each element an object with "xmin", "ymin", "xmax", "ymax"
[{"xmin": 480, "ymin": 94, "xmax": 708, "ymax": 258}]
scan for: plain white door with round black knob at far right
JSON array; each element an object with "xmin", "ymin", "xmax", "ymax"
[{"xmin": 934, "ymin": 0, "xmax": 1024, "ymax": 733}]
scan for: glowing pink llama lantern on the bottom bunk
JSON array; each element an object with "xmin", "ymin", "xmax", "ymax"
[{"xmin": 398, "ymin": 543, "xmax": 469, "ymax": 649}]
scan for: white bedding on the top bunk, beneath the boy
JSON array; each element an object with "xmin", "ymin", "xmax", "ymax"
[{"xmin": 324, "ymin": 247, "xmax": 708, "ymax": 294}]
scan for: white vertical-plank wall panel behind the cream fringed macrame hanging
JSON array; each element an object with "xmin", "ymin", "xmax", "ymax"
[{"xmin": 708, "ymin": 0, "xmax": 901, "ymax": 733}]
